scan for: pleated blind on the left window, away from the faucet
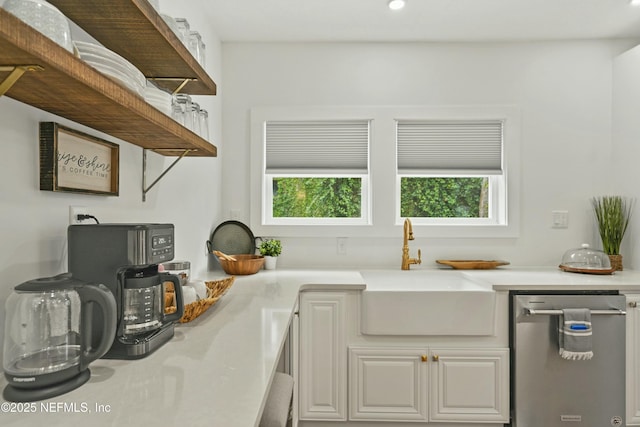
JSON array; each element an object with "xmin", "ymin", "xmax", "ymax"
[{"xmin": 265, "ymin": 120, "xmax": 369, "ymax": 174}]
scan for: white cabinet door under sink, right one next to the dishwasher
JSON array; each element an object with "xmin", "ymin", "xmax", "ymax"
[{"xmin": 429, "ymin": 348, "xmax": 509, "ymax": 422}]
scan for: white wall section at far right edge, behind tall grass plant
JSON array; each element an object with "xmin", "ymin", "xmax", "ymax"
[{"xmin": 610, "ymin": 46, "xmax": 640, "ymax": 269}]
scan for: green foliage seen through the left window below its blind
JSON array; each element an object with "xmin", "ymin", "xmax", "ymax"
[{"xmin": 273, "ymin": 178, "xmax": 362, "ymax": 218}]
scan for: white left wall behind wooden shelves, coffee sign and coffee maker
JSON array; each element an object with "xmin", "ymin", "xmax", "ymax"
[{"xmin": 0, "ymin": 2, "xmax": 224, "ymax": 357}]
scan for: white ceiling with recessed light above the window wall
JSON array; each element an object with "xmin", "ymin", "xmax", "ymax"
[{"xmin": 200, "ymin": 0, "xmax": 640, "ymax": 42}]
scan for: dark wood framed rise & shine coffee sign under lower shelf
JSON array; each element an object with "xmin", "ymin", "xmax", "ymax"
[{"xmin": 40, "ymin": 122, "xmax": 120, "ymax": 196}]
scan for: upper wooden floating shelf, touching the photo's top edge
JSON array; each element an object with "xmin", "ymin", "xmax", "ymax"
[{"xmin": 49, "ymin": 0, "xmax": 216, "ymax": 95}]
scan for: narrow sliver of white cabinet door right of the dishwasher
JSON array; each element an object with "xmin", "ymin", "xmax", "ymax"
[{"xmin": 626, "ymin": 294, "xmax": 640, "ymax": 426}]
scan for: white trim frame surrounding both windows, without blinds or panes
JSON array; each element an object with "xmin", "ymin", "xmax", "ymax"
[{"xmin": 248, "ymin": 105, "xmax": 521, "ymax": 241}]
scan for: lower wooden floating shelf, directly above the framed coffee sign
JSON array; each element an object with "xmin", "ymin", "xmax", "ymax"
[{"xmin": 0, "ymin": 7, "xmax": 217, "ymax": 157}]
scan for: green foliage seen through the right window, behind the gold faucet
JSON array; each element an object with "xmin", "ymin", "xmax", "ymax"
[{"xmin": 400, "ymin": 177, "xmax": 489, "ymax": 218}]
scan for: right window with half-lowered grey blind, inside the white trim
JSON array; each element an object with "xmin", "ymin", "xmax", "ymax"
[{"xmin": 396, "ymin": 120, "xmax": 505, "ymax": 223}]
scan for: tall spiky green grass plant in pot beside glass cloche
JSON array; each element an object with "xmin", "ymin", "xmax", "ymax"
[{"xmin": 592, "ymin": 196, "xmax": 633, "ymax": 270}]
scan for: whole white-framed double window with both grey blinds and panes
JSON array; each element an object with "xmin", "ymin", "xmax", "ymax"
[{"xmin": 248, "ymin": 105, "xmax": 522, "ymax": 238}]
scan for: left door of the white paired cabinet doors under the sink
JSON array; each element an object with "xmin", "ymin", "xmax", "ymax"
[{"xmin": 349, "ymin": 347, "xmax": 428, "ymax": 421}]
